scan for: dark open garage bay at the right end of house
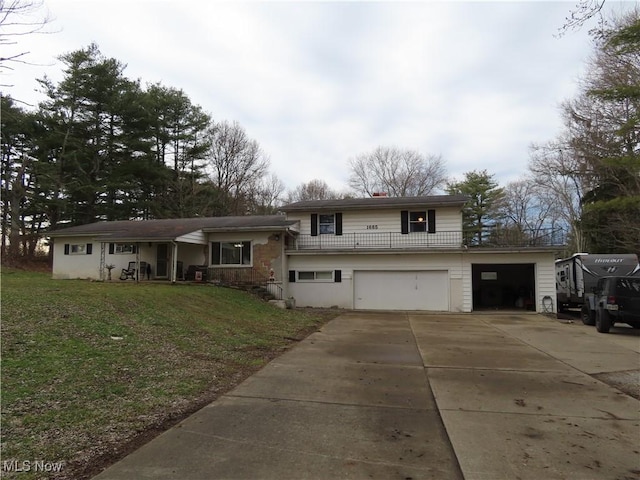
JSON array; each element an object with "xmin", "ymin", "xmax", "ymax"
[{"xmin": 471, "ymin": 263, "xmax": 536, "ymax": 310}]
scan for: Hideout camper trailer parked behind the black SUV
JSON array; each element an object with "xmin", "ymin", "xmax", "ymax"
[{"xmin": 556, "ymin": 253, "xmax": 640, "ymax": 325}]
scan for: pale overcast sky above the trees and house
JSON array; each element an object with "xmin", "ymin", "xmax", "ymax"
[{"xmin": 0, "ymin": 0, "xmax": 635, "ymax": 190}]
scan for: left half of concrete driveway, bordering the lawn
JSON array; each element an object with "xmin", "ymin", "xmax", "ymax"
[{"xmin": 96, "ymin": 313, "xmax": 463, "ymax": 480}]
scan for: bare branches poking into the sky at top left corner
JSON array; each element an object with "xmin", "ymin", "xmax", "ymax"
[{"xmin": 0, "ymin": 0, "xmax": 51, "ymax": 75}]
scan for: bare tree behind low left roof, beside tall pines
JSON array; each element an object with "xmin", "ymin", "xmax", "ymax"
[{"xmin": 207, "ymin": 121, "xmax": 269, "ymax": 215}]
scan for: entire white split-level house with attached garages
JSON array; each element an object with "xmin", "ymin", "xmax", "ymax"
[{"xmin": 51, "ymin": 195, "xmax": 563, "ymax": 312}]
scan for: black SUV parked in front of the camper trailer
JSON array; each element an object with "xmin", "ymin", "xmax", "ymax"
[{"xmin": 595, "ymin": 277, "xmax": 640, "ymax": 333}]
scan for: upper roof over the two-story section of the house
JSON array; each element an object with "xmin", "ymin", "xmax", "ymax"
[{"xmin": 280, "ymin": 195, "xmax": 468, "ymax": 212}]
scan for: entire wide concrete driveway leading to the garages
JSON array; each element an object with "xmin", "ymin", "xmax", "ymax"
[{"xmin": 96, "ymin": 312, "xmax": 640, "ymax": 480}]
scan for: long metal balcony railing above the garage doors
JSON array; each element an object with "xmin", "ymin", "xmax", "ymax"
[{"xmin": 287, "ymin": 229, "xmax": 565, "ymax": 250}]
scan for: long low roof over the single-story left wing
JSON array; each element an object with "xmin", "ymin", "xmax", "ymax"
[{"xmin": 48, "ymin": 215, "xmax": 297, "ymax": 241}]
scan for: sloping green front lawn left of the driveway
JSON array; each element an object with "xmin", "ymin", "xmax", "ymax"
[{"xmin": 0, "ymin": 269, "xmax": 338, "ymax": 478}]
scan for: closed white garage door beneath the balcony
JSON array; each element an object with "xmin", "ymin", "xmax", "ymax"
[{"xmin": 354, "ymin": 271, "xmax": 449, "ymax": 311}]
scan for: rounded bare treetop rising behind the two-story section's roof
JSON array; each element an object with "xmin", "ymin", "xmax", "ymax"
[{"xmin": 349, "ymin": 147, "xmax": 446, "ymax": 197}]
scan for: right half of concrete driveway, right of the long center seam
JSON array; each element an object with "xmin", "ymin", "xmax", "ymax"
[{"xmin": 410, "ymin": 315, "xmax": 640, "ymax": 480}]
